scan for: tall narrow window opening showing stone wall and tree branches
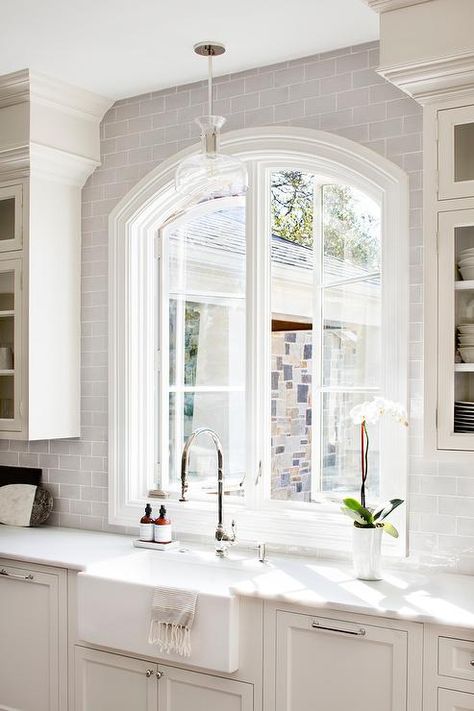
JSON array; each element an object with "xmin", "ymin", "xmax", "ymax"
[{"xmin": 270, "ymin": 170, "xmax": 314, "ymax": 501}]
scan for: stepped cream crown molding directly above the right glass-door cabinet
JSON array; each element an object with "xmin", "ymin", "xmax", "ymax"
[{"xmin": 377, "ymin": 52, "xmax": 474, "ymax": 104}]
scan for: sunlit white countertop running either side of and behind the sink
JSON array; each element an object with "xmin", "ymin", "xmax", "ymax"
[{"xmin": 0, "ymin": 526, "xmax": 474, "ymax": 629}]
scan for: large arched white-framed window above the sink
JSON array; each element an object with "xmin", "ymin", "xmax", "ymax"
[{"xmin": 110, "ymin": 129, "xmax": 408, "ymax": 552}]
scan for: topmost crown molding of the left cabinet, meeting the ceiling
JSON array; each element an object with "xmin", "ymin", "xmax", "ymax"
[{"xmin": 0, "ymin": 69, "xmax": 114, "ymax": 122}]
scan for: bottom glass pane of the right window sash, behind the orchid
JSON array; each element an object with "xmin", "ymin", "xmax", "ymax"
[{"xmin": 321, "ymin": 392, "xmax": 379, "ymax": 499}]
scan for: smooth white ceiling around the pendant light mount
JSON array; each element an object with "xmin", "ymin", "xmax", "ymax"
[{"xmin": 0, "ymin": 0, "xmax": 378, "ymax": 99}]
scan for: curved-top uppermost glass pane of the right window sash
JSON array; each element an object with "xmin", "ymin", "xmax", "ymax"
[{"xmin": 323, "ymin": 185, "xmax": 381, "ymax": 284}]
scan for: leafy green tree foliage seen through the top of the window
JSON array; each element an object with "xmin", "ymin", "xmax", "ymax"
[{"xmin": 271, "ymin": 170, "xmax": 380, "ymax": 270}]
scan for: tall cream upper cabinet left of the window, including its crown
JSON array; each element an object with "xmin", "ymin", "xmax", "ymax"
[{"xmin": 0, "ymin": 70, "xmax": 111, "ymax": 440}]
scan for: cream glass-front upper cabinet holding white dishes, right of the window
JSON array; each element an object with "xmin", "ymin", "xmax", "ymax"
[{"xmin": 423, "ymin": 97, "xmax": 474, "ymax": 456}]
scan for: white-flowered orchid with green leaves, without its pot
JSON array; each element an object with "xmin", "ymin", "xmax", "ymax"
[{"xmin": 342, "ymin": 397, "xmax": 408, "ymax": 538}]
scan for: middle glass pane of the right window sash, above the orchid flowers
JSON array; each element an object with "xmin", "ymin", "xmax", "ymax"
[{"xmin": 323, "ymin": 277, "xmax": 382, "ymax": 387}]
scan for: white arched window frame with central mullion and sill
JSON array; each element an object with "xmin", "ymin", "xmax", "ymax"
[{"xmin": 109, "ymin": 127, "xmax": 408, "ymax": 556}]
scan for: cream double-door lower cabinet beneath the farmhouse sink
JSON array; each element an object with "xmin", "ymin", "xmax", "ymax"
[{"xmin": 75, "ymin": 647, "xmax": 253, "ymax": 711}]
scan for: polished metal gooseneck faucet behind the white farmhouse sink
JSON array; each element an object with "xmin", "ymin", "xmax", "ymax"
[{"xmin": 180, "ymin": 427, "xmax": 236, "ymax": 558}]
